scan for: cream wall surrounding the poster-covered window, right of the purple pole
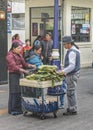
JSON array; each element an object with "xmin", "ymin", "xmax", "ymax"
[{"xmin": 64, "ymin": 0, "xmax": 93, "ymax": 67}]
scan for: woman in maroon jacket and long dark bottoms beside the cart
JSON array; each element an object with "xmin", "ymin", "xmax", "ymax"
[{"xmin": 6, "ymin": 42, "xmax": 35, "ymax": 115}]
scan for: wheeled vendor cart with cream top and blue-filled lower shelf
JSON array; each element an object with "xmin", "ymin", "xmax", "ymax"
[{"xmin": 20, "ymin": 78, "xmax": 62, "ymax": 119}]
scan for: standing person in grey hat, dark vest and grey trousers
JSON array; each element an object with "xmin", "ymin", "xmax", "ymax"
[{"xmin": 59, "ymin": 36, "xmax": 80, "ymax": 115}]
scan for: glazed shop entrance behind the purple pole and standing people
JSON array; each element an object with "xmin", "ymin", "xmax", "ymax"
[{"xmin": 30, "ymin": 7, "xmax": 61, "ymax": 43}]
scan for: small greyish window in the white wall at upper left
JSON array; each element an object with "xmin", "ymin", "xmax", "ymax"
[{"xmin": 12, "ymin": 14, "xmax": 25, "ymax": 30}]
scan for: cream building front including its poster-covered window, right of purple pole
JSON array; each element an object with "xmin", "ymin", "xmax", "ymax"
[{"xmin": 64, "ymin": 0, "xmax": 93, "ymax": 67}]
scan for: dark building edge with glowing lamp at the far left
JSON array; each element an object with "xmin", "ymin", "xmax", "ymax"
[{"xmin": 0, "ymin": 0, "xmax": 8, "ymax": 84}]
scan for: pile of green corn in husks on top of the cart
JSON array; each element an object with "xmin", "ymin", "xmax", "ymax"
[{"xmin": 26, "ymin": 65, "xmax": 64, "ymax": 85}]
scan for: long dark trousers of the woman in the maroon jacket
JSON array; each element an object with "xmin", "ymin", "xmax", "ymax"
[{"xmin": 8, "ymin": 73, "xmax": 22, "ymax": 114}]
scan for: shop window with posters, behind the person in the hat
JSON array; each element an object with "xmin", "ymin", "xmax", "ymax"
[{"xmin": 71, "ymin": 7, "xmax": 90, "ymax": 42}]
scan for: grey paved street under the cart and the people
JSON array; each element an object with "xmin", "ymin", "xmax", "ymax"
[{"xmin": 0, "ymin": 68, "xmax": 93, "ymax": 130}]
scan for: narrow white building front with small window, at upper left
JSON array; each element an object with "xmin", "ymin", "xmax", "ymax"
[{"xmin": 11, "ymin": 0, "xmax": 25, "ymax": 42}]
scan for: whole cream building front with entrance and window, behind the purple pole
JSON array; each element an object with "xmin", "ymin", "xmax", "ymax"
[{"xmin": 25, "ymin": 0, "xmax": 93, "ymax": 67}]
